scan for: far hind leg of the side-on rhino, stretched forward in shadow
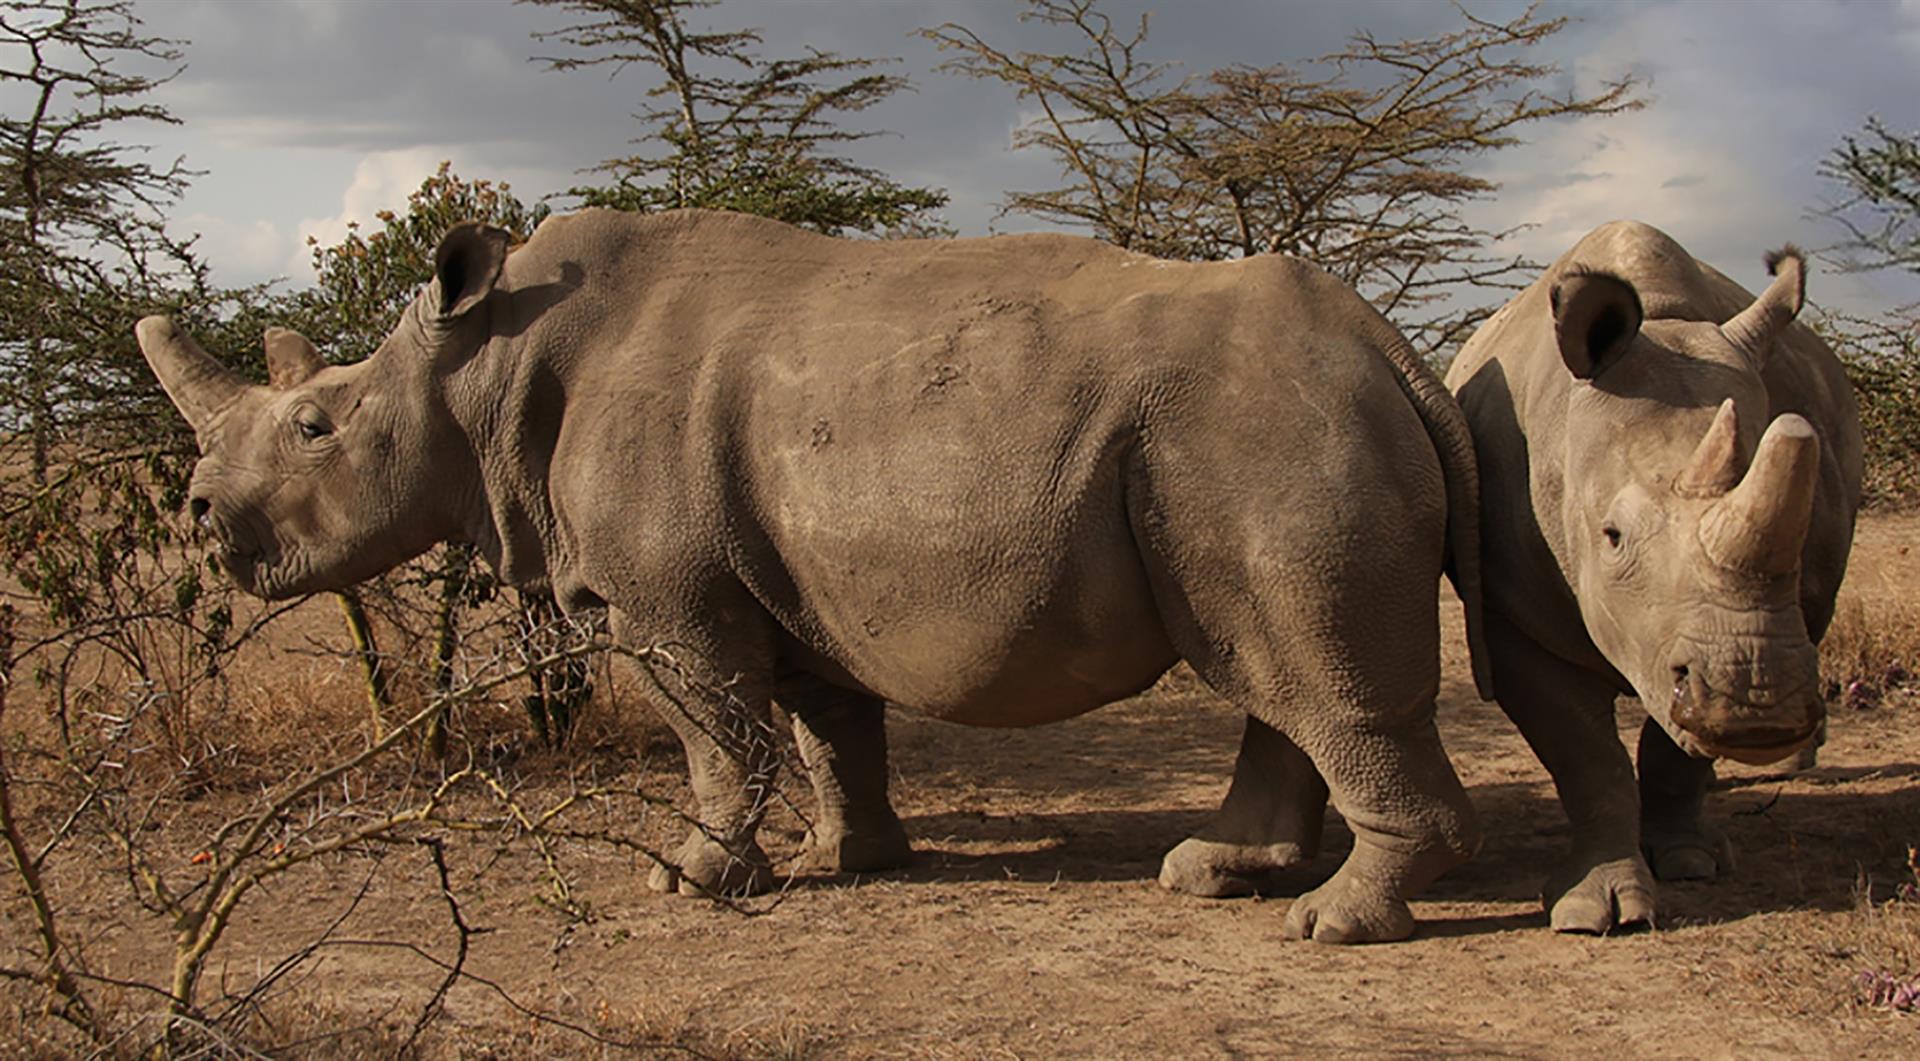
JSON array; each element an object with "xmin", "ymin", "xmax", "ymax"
[{"xmin": 1160, "ymin": 716, "xmax": 1327, "ymax": 898}]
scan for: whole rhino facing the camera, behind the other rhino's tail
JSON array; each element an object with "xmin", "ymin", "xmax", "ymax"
[{"xmin": 1448, "ymin": 221, "xmax": 1860, "ymax": 932}]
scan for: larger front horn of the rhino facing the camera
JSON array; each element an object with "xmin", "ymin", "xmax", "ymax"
[{"xmin": 1699, "ymin": 413, "xmax": 1820, "ymax": 576}]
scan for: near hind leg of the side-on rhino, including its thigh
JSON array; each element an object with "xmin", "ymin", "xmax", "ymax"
[{"xmin": 1127, "ymin": 458, "xmax": 1480, "ymax": 944}]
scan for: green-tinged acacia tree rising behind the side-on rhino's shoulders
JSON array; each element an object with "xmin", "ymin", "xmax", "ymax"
[{"xmin": 530, "ymin": 0, "xmax": 947, "ymax": 236}]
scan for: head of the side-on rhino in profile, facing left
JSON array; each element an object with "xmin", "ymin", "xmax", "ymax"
[{"xmin": 136, "ymin": 224, "xmax": 507, "ymax": 599}]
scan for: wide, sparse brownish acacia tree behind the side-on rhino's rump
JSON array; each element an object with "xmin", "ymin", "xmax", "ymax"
[{"xmin": 924, "ymin": 0, "xmax": 1642, "ymax": 351}]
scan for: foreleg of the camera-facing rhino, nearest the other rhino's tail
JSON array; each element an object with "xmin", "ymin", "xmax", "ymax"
[{"xmin": 1486, "ymin": 612, "xmax": 1655, "ymax": 934}]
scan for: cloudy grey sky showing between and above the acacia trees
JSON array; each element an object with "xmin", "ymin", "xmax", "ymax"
[{"xmin": 101, "ymin": 0, "xmax": 1920, "ymax": 313}]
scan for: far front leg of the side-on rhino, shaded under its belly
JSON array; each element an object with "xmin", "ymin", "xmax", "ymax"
[{"xmin": 778, "ymin": 675, "xmax": 912, "ymax": 873}]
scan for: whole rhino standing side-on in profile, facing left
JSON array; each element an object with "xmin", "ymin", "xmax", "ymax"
[{"xmin": 138, "ymin": 211, "xmax": 1478, "ymax": 942}]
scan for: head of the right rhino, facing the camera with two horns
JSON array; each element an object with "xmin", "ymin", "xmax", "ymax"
[{"xmin": 1551, "ymin": 248, "xmax": 1826, "ymax": 764}]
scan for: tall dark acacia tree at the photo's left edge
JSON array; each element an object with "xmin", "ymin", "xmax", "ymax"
[{"xmin": 0, "ymin": 0, "xmax": 192, "ymax": 483}]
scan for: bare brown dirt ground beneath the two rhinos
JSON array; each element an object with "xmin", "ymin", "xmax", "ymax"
[{"xmin": 15, "ymin": 516, "xmax": 1920, "ymax": 1057}]
